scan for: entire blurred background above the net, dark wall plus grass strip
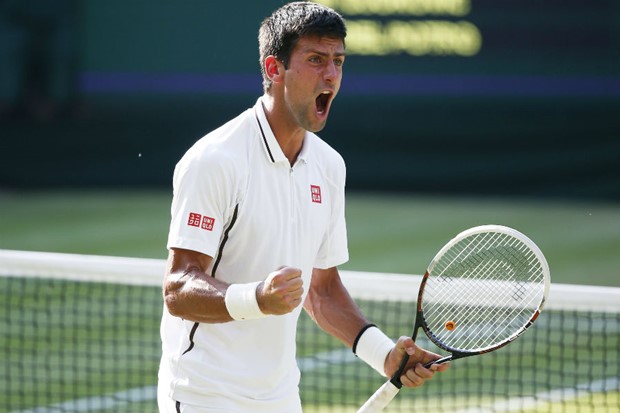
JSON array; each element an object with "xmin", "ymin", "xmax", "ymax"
[{"xmin": 0, "ymin": 0, "xmax": 620, "ymax": 285}]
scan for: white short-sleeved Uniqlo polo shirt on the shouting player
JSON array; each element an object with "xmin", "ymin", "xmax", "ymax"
[{"xmin": 159, "ymin": 98, "xmax": 348, "ymax": 413}]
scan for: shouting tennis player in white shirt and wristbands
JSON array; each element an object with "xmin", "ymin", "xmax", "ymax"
[{"xmin": 158, "ymin": 2, "xmax": 447, "ymax": 413}]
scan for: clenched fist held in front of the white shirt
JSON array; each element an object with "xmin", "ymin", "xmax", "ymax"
[{"xmin": 256, "ymin": 267, "xmax": 304, "ymax": 315}]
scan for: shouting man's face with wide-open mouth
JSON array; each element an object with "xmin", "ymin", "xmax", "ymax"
[{"xmin": 284, "ymin": 36, "xmax": 345, "ymax": 132}]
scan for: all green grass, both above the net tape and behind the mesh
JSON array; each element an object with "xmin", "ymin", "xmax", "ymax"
[{"xmin": 0, "ymin": 191, "xmax": 620, "ymax": 413}]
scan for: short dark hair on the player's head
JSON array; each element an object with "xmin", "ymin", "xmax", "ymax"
[{"xmin": 258, "ymin": 1, "xmax": 347, "ymax": 91}]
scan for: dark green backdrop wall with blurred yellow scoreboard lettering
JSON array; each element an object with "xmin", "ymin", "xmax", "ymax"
[{"xmin": 0, "ymin": 0, "xmax": 620, "ymax": 200}]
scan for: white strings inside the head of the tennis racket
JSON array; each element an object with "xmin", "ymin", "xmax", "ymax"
[{"xmin": 422, "ymin": 233, "xmax": 544, "ymax": 350}]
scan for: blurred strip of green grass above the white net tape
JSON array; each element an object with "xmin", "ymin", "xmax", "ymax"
[{"xmin": 0, "ymin": 191, "xmax": 620, "ymax": 286}]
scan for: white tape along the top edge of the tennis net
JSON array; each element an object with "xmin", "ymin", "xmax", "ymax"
[{"xmin": 0, "ymin": 250, "xmax": 620, "ymax": 313}]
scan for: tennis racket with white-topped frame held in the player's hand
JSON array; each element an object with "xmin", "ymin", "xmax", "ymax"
[{"xmin": 358, "ymin": 225, "xmax": 550, "ymax": 413}]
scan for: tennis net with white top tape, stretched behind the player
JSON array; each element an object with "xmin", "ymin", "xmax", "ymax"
[{"xmin": 0, "ymin": 250, "xmax": 620, "ymax": 413}]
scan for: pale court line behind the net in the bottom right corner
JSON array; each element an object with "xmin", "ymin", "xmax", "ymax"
[{"xmin": 455, "ymin": 377, "xmax": 620, "ymax": 413}]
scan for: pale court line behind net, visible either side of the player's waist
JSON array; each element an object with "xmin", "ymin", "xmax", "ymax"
[{"xmin": 11, "ymin": 349, "xmax": 357, "ymax": 413}]
